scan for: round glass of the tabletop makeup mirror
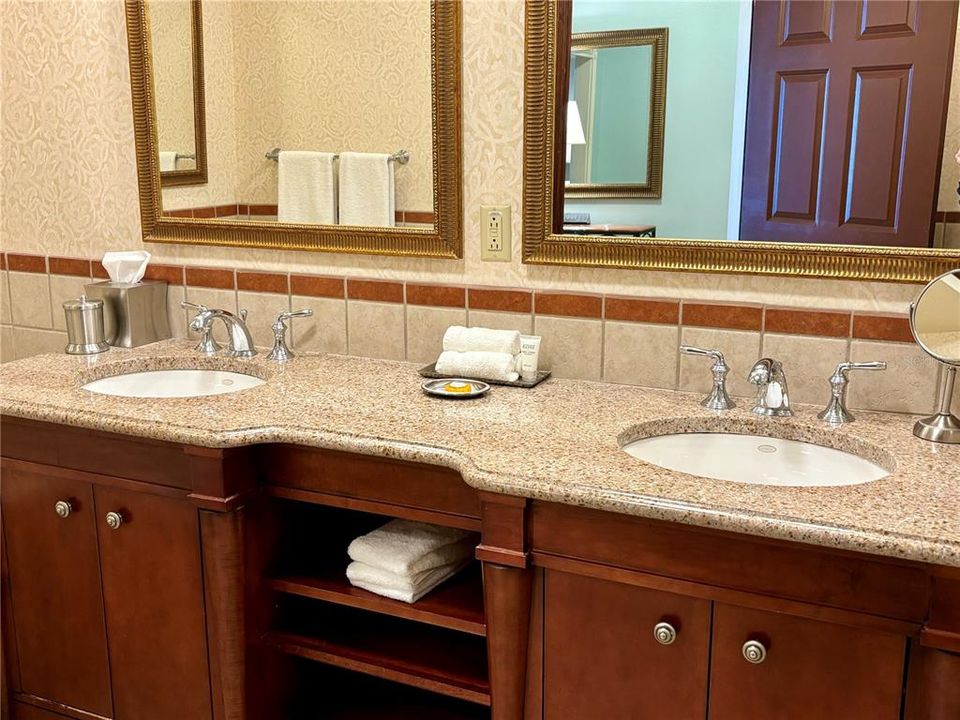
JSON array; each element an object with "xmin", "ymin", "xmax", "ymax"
[{"xmin": 910, "ymin": 270, "xmax": 960, "ymax": 365}]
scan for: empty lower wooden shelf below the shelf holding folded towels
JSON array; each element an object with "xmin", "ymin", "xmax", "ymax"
[{"xmin": 263, "ymin": 615, "xmax": 490, "ymax": 705}]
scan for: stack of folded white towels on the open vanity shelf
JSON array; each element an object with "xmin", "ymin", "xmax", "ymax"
[{"xmin": 347, "ymin": 520, "xmax": 478, "ymax": 603}]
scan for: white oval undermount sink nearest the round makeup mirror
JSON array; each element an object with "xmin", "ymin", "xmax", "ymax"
[{"xmin": 623, "ymin": 432, "xmax": 890, "ymax": 487}]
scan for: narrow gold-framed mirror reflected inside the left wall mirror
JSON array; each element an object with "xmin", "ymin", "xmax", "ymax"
[{"xmin": 149, "ymin": 0, "xmax": 207, "ymax": 187}]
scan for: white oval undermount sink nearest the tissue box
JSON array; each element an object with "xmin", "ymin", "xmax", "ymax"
[{"xmin": 83, "ymin": 370, "xmax": 265, "ymax": 398}]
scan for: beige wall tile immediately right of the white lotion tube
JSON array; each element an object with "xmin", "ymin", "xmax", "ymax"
[{"xmin": 533, "ymin": 315, "xmax": 603, "ymax": 380}]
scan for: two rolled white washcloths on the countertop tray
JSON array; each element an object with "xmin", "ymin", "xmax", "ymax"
[{"xmin": 435, "ymin": 325, "xmax": 520, "ymax": 382}]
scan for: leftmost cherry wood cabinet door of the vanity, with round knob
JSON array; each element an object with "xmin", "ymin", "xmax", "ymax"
[{"xmin": 0, "ymin": 462, "xmax": 112, "ymax": 717}]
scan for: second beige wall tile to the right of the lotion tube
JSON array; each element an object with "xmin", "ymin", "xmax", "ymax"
[{"xmin": 603, "ymin": 321, "xmax": 680, "ymax": 390}]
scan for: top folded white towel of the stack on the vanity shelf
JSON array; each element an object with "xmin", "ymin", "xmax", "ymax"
[{"xmin": 347, "ymin": 520, "xmax": 477, "ymax": 575}]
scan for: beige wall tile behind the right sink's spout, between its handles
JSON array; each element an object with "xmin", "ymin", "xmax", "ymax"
[{"xmin": 762, "ymin": 333, "xmax": 848, "ymax": 406}]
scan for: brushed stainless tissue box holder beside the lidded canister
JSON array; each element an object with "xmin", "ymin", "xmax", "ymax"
[{"xmin": 86, "ymin": 280, "xmax": 170, "ymax": 347}]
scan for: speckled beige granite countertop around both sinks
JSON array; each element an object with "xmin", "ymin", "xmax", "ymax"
[{"xmin": 0, "ymin": 340, "xmax": 960, "ymax": 567}]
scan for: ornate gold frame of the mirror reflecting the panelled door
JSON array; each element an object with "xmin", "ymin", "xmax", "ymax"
[{"xmin": 523, "ymin": 0, "xmax": 960, "ymax": 283}]
